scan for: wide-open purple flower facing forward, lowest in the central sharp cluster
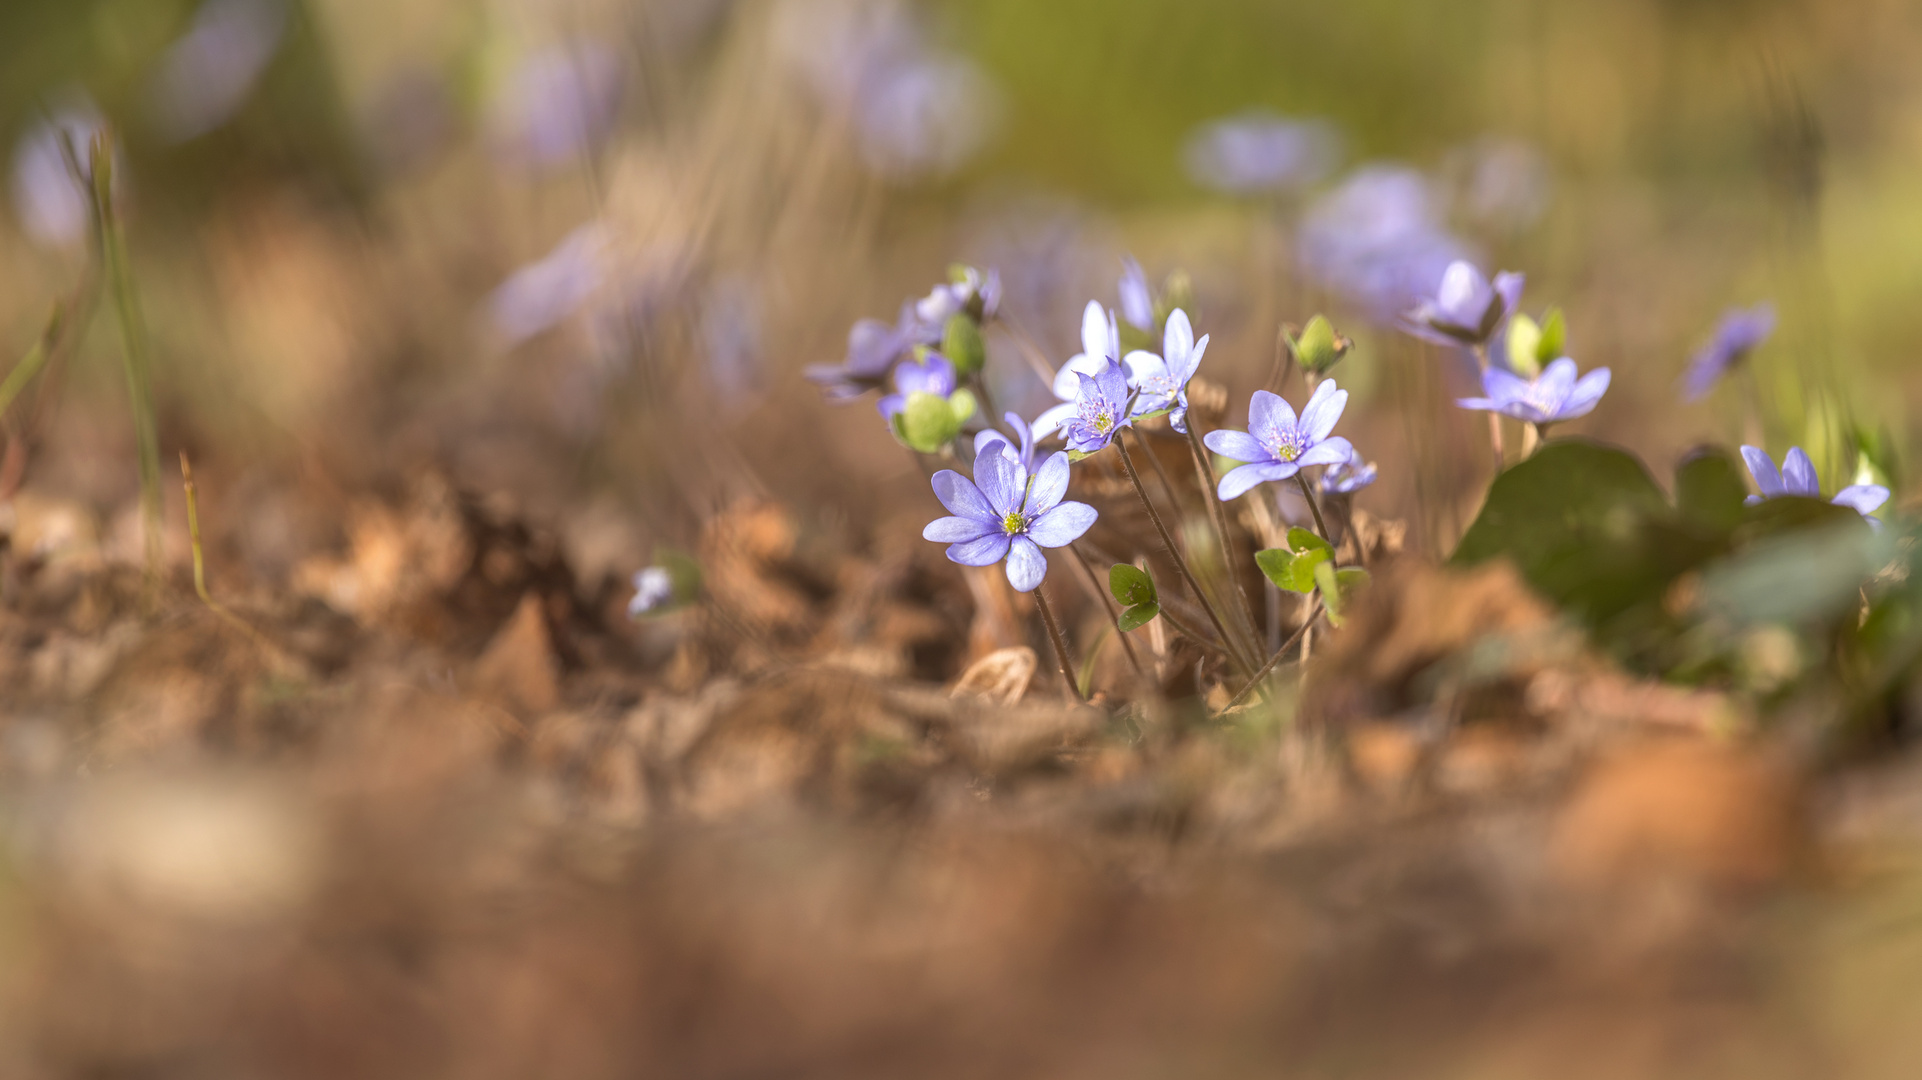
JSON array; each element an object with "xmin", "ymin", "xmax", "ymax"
[{"xmin": 921, "ymin": 448, "xmax": 1097, "ymax": 592}]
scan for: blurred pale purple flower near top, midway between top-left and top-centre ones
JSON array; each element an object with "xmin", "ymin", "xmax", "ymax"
[{"xmin": 488, "ymin": 40, "xmax": 623, "ymax": 165}]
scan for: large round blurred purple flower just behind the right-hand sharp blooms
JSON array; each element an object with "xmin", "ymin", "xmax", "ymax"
[{"xmin": 1299, "ymin": 165, "xmax": 1466, "ymax": 323}]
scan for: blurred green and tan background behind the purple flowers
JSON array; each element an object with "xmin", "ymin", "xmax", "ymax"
[{"xmin": 0, "ymin": 0, "xmax": 1922, "ymax": 578}]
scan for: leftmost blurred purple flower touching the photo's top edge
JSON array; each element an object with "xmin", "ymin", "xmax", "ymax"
[{"xmin": 152, "ymin": 0, "xmax": 286, "ymax": 142}]
